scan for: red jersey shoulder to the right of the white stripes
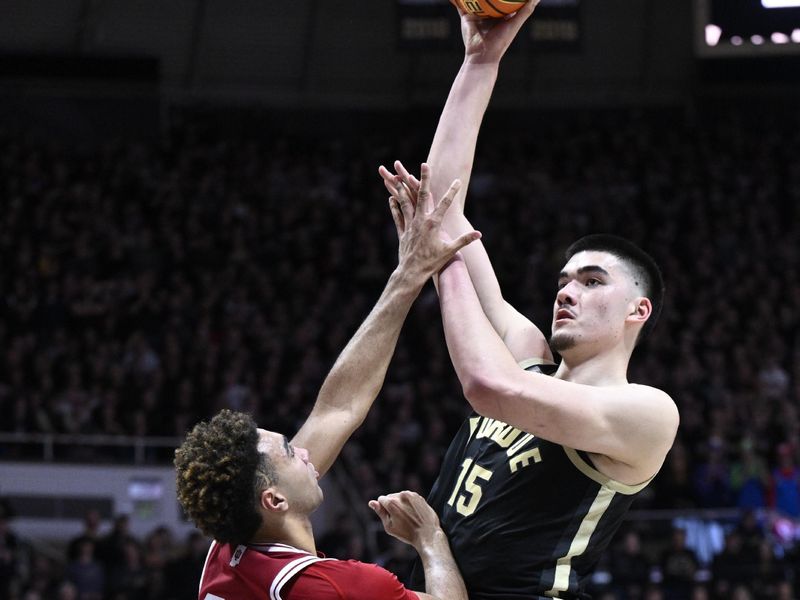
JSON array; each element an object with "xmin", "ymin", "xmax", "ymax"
[{"xmin": 290, "ymin": 560, "xmax": 418, "ymax": 600}]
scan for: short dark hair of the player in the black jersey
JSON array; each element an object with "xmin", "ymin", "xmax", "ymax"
[{"xmin": 565, "ymin": 233, "xmax": 665, "ymax": 343}]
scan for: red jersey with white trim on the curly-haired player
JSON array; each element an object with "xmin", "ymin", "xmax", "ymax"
[{"xmin": 199, "ymin": 542, "xmax": 419, "ymax": 600}]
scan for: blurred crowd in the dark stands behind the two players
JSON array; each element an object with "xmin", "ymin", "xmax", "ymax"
[{"xmin": 0, "ymin": 108, "xmax": 800, "ymax": 600}]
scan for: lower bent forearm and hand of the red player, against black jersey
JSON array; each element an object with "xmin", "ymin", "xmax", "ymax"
[{"xmin": 369, "ymin": 491, "xmax": 467, "ymax": 600}]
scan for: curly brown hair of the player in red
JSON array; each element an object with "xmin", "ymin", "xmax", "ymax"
[{"xmin": 175, "ymin": 409, "xmax": 277, "ymax": 544}]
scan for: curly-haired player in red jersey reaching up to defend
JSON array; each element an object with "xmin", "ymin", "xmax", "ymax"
[{"xmin": 175, "ymin": 173, "xmax": 479, "ymax": 600}]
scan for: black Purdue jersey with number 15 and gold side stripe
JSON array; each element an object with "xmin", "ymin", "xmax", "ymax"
[{"xmin": 411, "ymin": 360, "xmax": 648, "ymax": 600}]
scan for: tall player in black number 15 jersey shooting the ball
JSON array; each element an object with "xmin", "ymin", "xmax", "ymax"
[{"xmin": 381, "ymin": 0, "xmax": 678, "ymax": 600}]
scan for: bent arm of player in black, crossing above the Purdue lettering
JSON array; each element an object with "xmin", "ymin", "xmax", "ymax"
[{"xmin": 439, "ymin": 258, "xmax": 678, "ymax": 485}]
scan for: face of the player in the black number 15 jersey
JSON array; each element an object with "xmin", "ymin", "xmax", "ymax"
[{"xmin": 550, "ymin": 251, "xmax": 636, "ymax": 354}]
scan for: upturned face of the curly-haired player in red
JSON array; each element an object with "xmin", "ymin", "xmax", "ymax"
[{"xmin": 258, "ymin": 429, "xmax": 322, "ymax": 512}]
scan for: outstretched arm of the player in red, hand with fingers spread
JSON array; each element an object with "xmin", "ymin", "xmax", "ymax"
[{"xmin": 292, "ymin": 175, "xmax": 480, "ymax": 475}]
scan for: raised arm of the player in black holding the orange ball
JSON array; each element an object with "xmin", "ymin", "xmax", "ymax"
[{"xmin": 381, "ymin": 0, "xmax": 552, "ymax": 360}]
